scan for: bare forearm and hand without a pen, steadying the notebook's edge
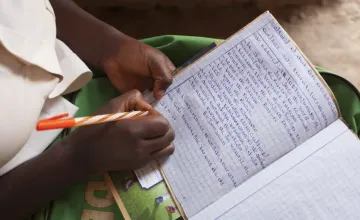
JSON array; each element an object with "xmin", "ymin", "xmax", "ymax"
[{"xmin": 51, "ymin": 0, "xmax": 175, "ymax": 99}]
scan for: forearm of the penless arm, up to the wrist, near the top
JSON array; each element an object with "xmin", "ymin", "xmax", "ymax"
[{"xmin": 51, "ymin": 0, "xmax": 126, "ymax": 67}]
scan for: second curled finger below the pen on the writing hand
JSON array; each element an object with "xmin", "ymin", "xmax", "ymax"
[{"xmin": 144, "ymin": 129, "xmax": 175, "ymax": 154}]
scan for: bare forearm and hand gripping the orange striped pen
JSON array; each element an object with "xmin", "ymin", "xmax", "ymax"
[{"xmin": 0, "ymin": 90, "xmax": 174, "ymax": 219}]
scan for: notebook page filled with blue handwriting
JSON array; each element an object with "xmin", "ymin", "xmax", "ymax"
[{"xmin": 155, "ymin": 13, "xmax": 338, "ymax": 217}]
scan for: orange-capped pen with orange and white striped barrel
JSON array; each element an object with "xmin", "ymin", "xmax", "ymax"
[{"xmin": 36, "ymin": 111, "xmax": 149, "ymax": 131}]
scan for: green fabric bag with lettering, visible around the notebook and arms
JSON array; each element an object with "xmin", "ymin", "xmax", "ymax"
[{"xmin": 33, "ymin": 36, "xmax": 360, "ymax": 220}]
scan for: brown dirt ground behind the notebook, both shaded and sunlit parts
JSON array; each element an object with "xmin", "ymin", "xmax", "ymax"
[{"xmin": 79, "ymin": 0, "xmax": 360, "ymax": 89}]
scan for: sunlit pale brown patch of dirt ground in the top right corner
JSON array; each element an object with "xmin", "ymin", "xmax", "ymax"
[{"xmin": 283, "ymin": 0, "xmax": 360, "ymax": 89}]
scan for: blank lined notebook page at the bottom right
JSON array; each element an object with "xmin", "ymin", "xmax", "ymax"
[{"xmin": 190, "ymin": 120, "xmax": 352, "ymax": 220}]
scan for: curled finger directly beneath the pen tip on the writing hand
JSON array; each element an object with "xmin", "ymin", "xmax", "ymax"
[{"xmin": 117, "ymin": 115, "xmax": 170, "ymax": 139}]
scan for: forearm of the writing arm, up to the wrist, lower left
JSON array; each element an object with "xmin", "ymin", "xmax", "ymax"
[{"xmin": 0, "ymin": 140, "xmax": 85, "ymax": 219}]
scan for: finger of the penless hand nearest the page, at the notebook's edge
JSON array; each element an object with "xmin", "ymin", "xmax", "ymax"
[{"xmin": 151, "ymin": 55, "xmax": 175, "ymax": 100}]
